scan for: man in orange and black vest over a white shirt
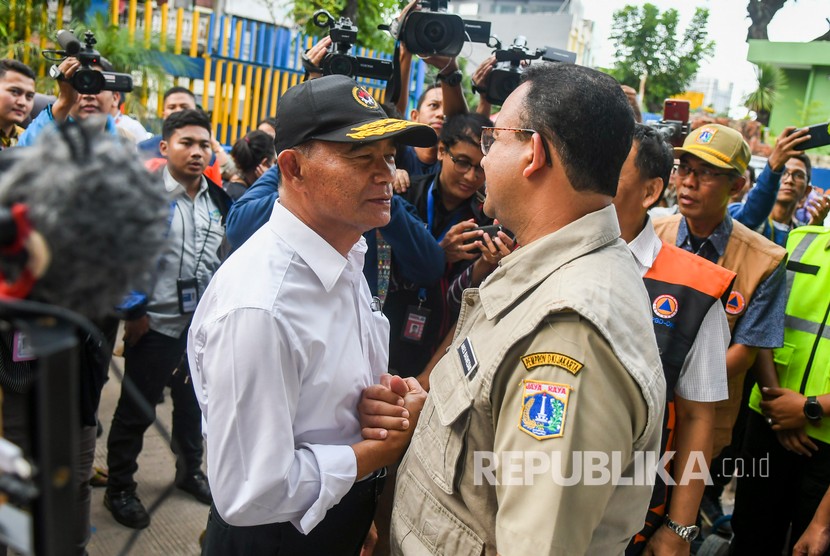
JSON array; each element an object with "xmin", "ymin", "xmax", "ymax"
[{"xmin": 614, "ymin": 124, "xmax": 735, "ymax": 555}]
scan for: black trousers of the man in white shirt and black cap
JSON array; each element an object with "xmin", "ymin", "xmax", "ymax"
[{"xmin": 202, "ymin": 475, "xmax": 385, "ymax": 556}]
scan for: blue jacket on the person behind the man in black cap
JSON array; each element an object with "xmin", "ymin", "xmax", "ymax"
[{"xmin": 225, "ymin": 166, "xmax": 444, "ymax": 295}]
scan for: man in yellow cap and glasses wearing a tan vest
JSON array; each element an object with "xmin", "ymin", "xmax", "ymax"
[{"xmin": 654, "ymin": 124, "xmax": 787, "ymax": 532}]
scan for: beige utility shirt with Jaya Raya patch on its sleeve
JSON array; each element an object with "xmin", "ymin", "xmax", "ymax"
[{"xmin": 392, "ymin": 207, "xmax": 665, "ymax": 556}]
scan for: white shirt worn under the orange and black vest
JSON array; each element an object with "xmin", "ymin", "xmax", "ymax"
[{"xmin": 628, "ymin": 220, "xmax": 731, "ymax": 402}]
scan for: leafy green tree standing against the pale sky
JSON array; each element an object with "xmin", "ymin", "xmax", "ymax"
[{"xmin": 610, "ymin": 4, "xmax": 715, "ymax": 112}]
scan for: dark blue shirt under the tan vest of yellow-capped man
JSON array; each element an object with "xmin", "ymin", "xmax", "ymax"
[{"xmin": 676, "ymin": 215, "xmax": 787, "ymax": 348}]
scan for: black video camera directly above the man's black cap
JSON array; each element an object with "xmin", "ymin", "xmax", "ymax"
[{"xmin": 312, "ymin": 10, "xmax": 394, "ymax": 81}]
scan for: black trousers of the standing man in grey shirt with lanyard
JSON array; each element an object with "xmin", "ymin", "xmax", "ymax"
[{"xmin": 107, "ymin": 330, "xmax": 204, "ymax": 492}]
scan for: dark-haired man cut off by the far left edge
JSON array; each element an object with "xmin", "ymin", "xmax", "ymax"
[{"xmin": 0, "ymin": 59, "xmax": 35, "ymax": 150}]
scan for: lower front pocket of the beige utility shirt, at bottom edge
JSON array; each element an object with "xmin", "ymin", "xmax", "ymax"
[{"xmin": 392, "ymin": 472, "xmax": 484, "ymax": 556}]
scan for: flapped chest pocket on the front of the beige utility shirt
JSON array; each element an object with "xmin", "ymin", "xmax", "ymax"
[{"xmin": 412, "ymin": 351, "xmax": 473, "ymax": 494}]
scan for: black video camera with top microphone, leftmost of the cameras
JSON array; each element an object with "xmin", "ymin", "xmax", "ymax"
[{"xmin": 43, "ymin": 29, "xmax": 133, "ymax": 95}]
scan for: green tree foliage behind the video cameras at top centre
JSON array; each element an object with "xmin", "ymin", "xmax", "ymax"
[{"xmin": 292, "ymin": 0, "xmax": 403, "ymax": 52}]
